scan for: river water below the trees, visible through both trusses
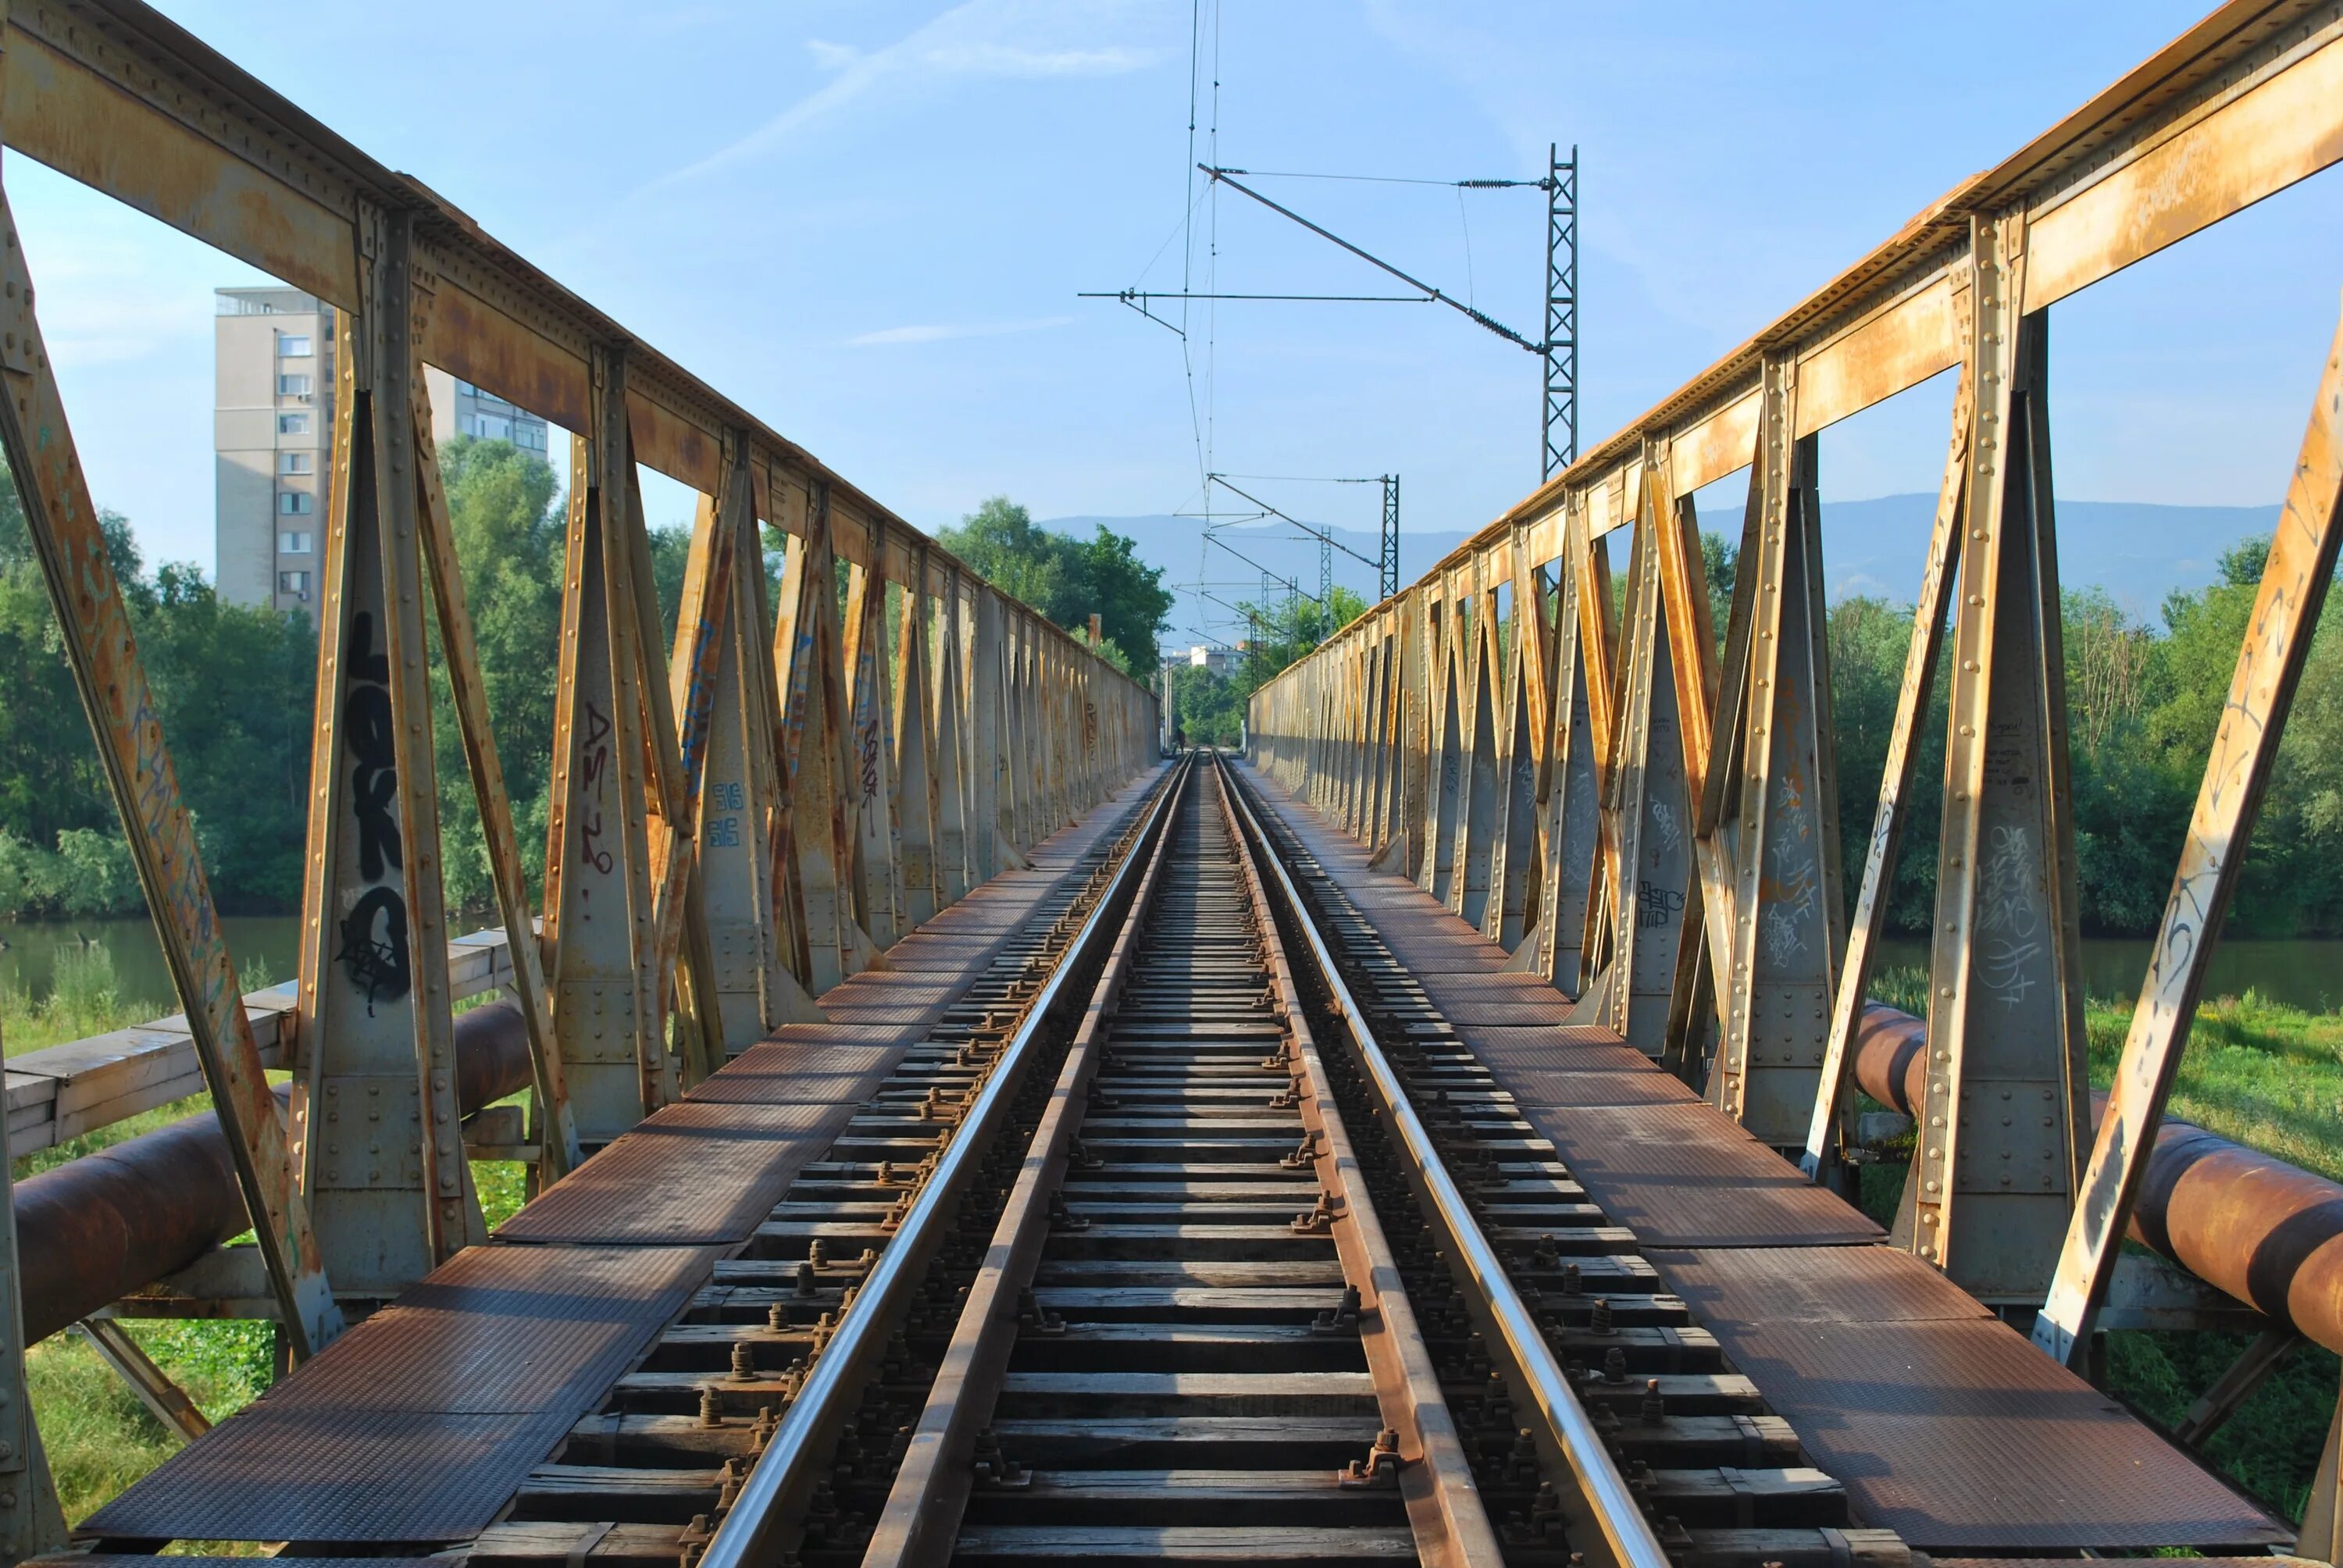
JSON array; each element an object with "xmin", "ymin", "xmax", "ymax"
[{"xmin": 0, "ymin": 914, "xmax": 2343, "ymax": 1017}]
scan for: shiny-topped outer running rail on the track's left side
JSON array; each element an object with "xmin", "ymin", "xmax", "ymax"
[{"xmin": 701, "ymin": 764, "xmax": 1188, "ymax": 1568}]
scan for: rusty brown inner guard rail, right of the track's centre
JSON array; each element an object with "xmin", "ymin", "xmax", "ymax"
[{"xmin": 1214, "ymin": 766, "xmax": 1504, "ymax": 1568}]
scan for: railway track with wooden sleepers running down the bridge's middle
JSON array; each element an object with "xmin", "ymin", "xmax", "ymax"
[{"xmin": 469, "ymin": 757, "xmax": 1910, "ymax": 1568}]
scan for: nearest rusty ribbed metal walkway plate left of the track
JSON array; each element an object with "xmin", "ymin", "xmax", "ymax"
[{"xmin": 82, "ymin": 1247, "xmax": 715, "ymax": 1537}]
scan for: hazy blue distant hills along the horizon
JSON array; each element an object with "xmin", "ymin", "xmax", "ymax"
[{"xmin": 1043, "ymin": 494, "xmax": 2277, "ymax": 649}]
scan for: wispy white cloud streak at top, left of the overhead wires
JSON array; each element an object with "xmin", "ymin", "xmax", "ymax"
[{"xmin": 644, "ymin": 0, "xmax": 1160, "ymax": 190}]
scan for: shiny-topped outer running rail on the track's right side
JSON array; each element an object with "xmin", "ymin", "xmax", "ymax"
[{"xmin": 1223, "ymin": 764, "xmax": 1668, "ymax": 1568}]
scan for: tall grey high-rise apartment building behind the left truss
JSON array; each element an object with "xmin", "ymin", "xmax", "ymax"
[{"xmin": 211, "ymin": 288, "xmax": 548, "ymax": 611}]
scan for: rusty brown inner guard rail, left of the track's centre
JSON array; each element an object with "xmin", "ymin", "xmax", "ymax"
[{"xmin": 862, "ymin": 750, "xmax": 1195, "ymax": 1568}]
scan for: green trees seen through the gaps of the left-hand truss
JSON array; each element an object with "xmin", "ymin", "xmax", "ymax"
[{"xmin": 0, "ymin": 438, "xmax": 691, "ymax": 919}]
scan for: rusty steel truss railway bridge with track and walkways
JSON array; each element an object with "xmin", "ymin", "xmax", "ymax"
[{"xmin": 0, "ymin": 0, "xmax": 2343, "ymax": 1568}]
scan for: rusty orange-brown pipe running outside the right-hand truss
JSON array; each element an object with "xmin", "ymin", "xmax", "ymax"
[{"xmin": 1856, "ymin": 1001, "xmax": 2343, "ymax": 1350}]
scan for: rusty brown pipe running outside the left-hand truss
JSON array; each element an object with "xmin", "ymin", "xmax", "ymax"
[{"xmin": 16, "ymin": 1001, "xmax": 530, "ymax": 1343}]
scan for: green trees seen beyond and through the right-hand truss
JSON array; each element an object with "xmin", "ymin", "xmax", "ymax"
[{"xmin": 1172, "ymin": 534, "xmax": 2343, "ymax": 938}]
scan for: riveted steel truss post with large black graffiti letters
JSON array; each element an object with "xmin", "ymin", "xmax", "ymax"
[{"xmin": 293, "ymin": 206, "xmax": 487, "ymax": 1296}]
